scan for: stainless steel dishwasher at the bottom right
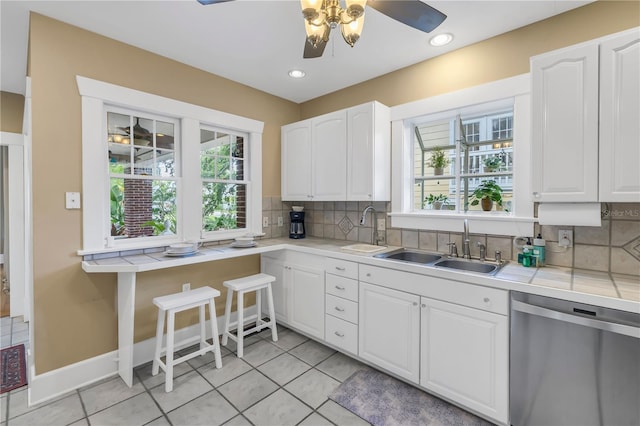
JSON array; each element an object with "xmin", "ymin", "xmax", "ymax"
[{"xmin": 510, "ymin": 292, "xmax": 640, "ymax": 426}]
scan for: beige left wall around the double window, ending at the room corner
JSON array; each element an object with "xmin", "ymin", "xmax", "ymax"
[{"xmin": 29, "ymin": 14, "xmax": 299, "ymax": 374}]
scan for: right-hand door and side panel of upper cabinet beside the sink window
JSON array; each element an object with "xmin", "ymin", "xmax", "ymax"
[{"xmin": 347, "ymin": 102, "xmax": 391, "ymax": 201}]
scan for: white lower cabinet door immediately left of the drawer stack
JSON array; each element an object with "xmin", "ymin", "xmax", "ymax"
[{"xmin": 285, "ymin": 265, "xmax": 325, "ymax": 339}]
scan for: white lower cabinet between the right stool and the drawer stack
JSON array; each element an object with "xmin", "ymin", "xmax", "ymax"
[{"xmin": 261, "ymin": 252, "xmax": 325, "ymax": 339}]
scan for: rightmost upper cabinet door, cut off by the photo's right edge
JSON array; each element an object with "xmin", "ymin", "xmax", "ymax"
[{"xmin": 600, "ymin": 30, "xmax": 640, "ymax": 202}]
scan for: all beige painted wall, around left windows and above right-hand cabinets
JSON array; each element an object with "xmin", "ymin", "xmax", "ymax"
[{"xmin": 29, "ymin": 2, "xmax": 640, "ymax": 374}]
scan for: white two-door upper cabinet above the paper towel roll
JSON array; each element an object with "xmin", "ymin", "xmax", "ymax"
[{"xmin": 531, "ymin": 28, "xmax": 640, "ymax": 202}]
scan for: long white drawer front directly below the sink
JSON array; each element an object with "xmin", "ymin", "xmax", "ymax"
[{"xmin": 360, "ymin": 264, "xmax": 509, "ymax": 315}]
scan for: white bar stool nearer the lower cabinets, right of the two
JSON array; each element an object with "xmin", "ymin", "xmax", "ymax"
[{"xmin": 222, "ymin": 273, "xmax": 278, "ymax": 358}]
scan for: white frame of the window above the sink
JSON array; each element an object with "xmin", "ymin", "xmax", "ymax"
[{"xmin": 389, "ymin": 73, "xmax": 535, "ymax": 235}]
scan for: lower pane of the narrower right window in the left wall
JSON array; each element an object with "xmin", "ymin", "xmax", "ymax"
[{"xmin": 202, "ymin": 182, "xmax": 247, "ymax": 231}]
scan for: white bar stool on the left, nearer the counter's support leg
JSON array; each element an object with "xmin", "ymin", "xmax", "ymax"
[{"xmin": 151, "ymin": 287, "xmax": 222, "ymax": 392}]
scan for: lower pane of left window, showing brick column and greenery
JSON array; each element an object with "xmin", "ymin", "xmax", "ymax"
[{"xmin": 110, "ymin": 178, "xmax": 176, "ymax": 238}]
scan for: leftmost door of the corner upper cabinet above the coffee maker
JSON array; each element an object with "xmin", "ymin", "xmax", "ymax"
[{"xmin": 281, "ymin": 120, "xmax": 311, "ymax": 201}]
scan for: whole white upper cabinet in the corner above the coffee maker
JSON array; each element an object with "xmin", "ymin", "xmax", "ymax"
[{"xmin": 282, "ymin": 102, "xmax": 391, "ymax": 201}]
